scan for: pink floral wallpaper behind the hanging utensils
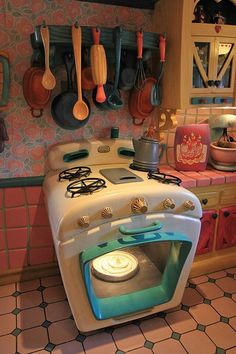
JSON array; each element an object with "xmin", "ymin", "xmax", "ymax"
[{"xmin": 0, "ymin": 0, "xmax": 151, "ymax": 178}]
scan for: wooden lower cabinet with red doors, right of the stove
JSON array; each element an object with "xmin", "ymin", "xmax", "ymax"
[{"xmin": 190, "ymin": 183, "xmax": 236, "ymax": 277}]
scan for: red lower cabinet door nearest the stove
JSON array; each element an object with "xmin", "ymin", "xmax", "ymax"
[{"xmin": 196, "ymin": 210, "xmax": 217, "ymax": 255}]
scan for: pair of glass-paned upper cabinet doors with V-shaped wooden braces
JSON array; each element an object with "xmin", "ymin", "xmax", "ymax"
[{"xmin": 192, "ymin": 36, "xmax": 236, "ymax": 92}]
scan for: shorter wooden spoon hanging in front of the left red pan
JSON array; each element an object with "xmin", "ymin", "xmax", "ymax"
[{"xmin": 40, "ymin": 25, "xmax": 56, "ymax": 90}]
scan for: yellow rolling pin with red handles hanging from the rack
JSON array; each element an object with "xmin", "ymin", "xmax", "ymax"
[{"xmin": 90, "ymin": 28, "xmax": 107, "ymax": 103}]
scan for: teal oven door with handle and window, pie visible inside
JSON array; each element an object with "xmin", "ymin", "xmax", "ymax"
[{"xmin": 80, "ymin": 222, "xmax": 192, "ymax": 320}]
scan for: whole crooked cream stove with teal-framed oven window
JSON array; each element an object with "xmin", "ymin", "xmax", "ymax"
[{"xmin": 44, "ymin": 139, "xmax": 202, "ymax": 332}]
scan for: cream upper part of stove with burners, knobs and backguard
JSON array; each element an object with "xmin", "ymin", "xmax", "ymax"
[{"xmin": 43, "ymin": 140, "xmax": 201, "ymax": 238}]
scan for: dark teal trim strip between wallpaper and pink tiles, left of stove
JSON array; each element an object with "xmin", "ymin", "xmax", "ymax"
[{"xmin": 0, "ymin": 176, "xmax": 45, "ymax": 188}]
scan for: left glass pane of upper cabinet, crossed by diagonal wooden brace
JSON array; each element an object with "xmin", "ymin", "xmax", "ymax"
[{"xmin": 193, "ymin": 42, "xmax": 210, "ymax": 88}]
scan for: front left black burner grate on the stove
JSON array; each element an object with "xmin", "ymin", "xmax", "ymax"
[{"xmin": 66, "ymin": 178, "xmax": 106, "ymax": 198}]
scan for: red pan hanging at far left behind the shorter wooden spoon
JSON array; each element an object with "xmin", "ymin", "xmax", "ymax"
[{"xmin": 23, "ymin": 67, "xmax": 51, "ymax": 118}]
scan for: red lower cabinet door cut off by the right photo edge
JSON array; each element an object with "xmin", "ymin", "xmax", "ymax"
[{"xmin": 216, "ymin": 206, "xmax": 236, "ymax": 250}]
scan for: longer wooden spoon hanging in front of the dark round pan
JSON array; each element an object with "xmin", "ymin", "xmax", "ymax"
[{"xmin": 72, "ymin": 24, "xmax": 89, "ymax": 120}]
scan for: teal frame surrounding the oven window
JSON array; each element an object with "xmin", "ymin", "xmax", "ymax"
[{"xmin": 80, "ymin": 232, "xmax": 192, "ymax": 320}]
